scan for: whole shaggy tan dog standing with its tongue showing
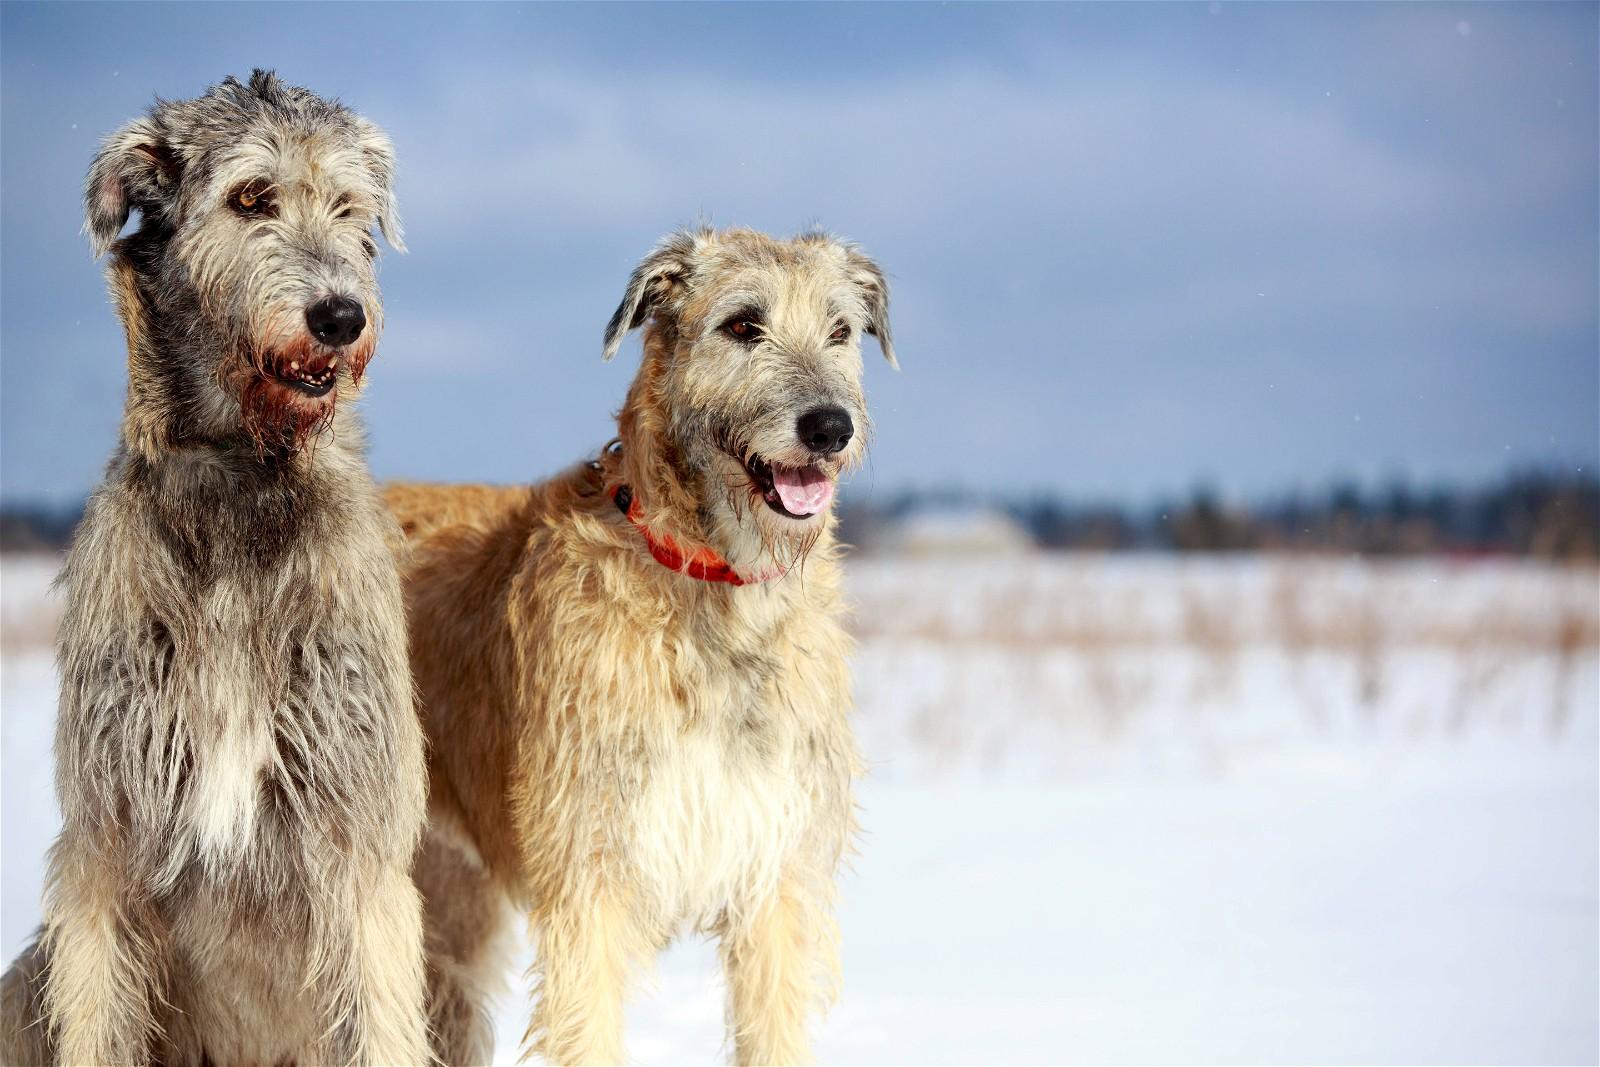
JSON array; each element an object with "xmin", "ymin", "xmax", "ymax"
[{"xmin": 387, "ymin": 230, "xmax": 893, "ymax": 1064}]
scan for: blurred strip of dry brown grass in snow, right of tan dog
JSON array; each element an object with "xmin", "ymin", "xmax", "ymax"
[{"xmin": 851, "ymin": 557, "xmax": 1600, "ymax": 750}]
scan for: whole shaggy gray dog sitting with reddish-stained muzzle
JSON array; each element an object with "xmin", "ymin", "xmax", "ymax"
[{"xmin": 0, "ymin": 70, "xmax": 427, "ymax": 1067}]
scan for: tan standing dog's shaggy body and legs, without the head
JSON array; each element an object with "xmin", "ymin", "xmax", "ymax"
[{"xmin": 387, "ymin": 453, "xmax": 858, "ymax": 1062}]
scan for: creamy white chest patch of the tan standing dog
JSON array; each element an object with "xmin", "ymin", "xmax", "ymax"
[{"xmin": 626, "ymin": 723, "xmax": 811, "ymax": 926}]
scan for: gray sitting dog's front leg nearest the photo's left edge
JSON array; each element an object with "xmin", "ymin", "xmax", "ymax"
[{"xmin": 43, "ymin": 837, "xmax": 166, "ymax": 1067}]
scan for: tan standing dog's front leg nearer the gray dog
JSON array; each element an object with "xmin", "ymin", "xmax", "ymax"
[{"xmin": 523, "ymin": 893, "xmax": 650, "ymax": 1064}]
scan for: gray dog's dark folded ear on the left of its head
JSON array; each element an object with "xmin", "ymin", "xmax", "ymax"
[{"xmin": 83, "ymin": 117, "xmax": 184, "ymax": 256}]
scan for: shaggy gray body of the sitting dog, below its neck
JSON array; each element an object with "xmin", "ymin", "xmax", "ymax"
[{"xmin": 0, "ymin": 340, "xmax": 426, "ymax": 1064}]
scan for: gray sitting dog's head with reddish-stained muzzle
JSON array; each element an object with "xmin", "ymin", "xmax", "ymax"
[{"xmin": 85, "ymin": 70, "xmax": 402, "ymax": 445}]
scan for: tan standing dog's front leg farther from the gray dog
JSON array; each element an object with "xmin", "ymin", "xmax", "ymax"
[{"xmin": 722, "ymin": 883, "xmax": 838, "ymax": 1064}]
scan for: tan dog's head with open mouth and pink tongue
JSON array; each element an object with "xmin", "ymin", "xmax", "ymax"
[{"xmin": 605, "ymin": 229, "xmax": 894, "ymax": 568}]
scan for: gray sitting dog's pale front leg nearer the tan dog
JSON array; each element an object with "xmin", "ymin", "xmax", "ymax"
[{"xmin": 352, "ymin": 867, "xmax": 432, "ymax": 1067}]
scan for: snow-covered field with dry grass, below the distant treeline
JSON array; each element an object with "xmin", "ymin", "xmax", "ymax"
[{"xmin": 0, "ymin": 557, "xmax": 1600, "ymax": 1062}]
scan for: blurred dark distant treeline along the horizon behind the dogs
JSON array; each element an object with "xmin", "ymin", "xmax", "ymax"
[{"xmin": 0, "ymin": 472, "xmax": 1600, "ymax": 560}]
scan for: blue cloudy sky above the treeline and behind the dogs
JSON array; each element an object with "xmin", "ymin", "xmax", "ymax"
[{"xmin": 0, "ymin": 3, "xmax": 1600, "ymax": 502}]
